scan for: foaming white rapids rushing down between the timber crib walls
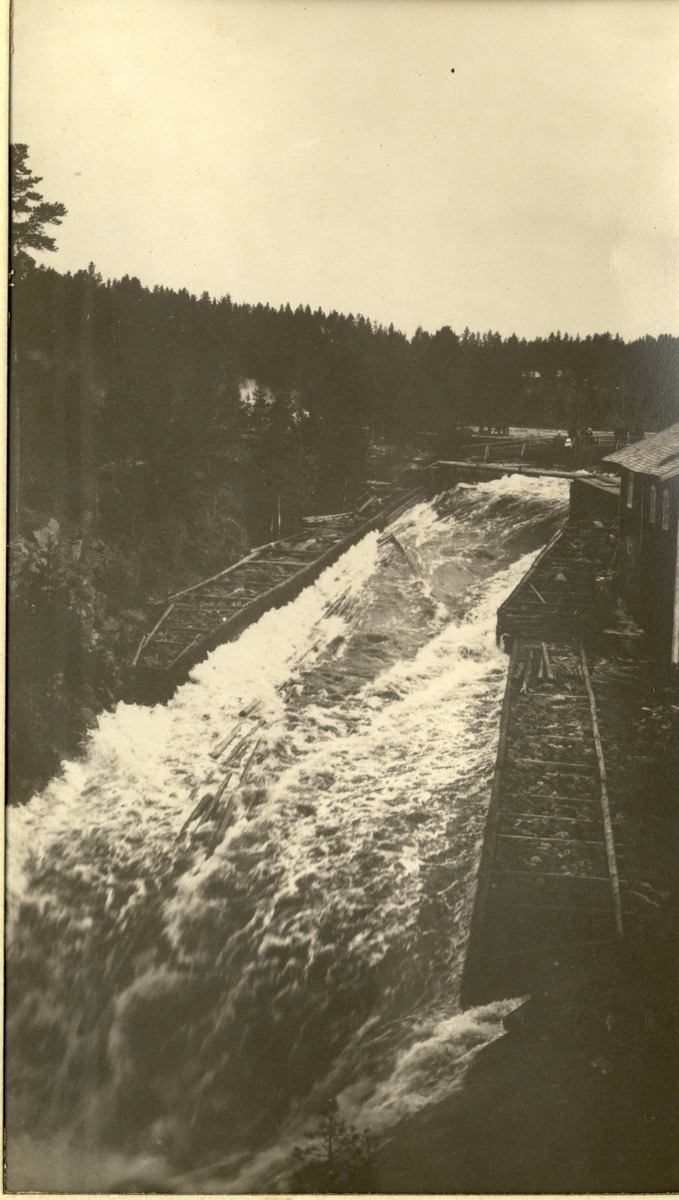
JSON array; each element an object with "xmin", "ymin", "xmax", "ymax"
[{"xmin": 6, "ymin": 476, "xmax": 567, "ymax": 1193}]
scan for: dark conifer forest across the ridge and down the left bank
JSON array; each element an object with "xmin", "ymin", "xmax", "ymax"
[{"xmin": 8, "ymin": 146, "xmax": 679, "ymax": 800}]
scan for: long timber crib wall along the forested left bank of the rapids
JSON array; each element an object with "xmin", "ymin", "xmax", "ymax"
[{"xmin": 132, "ymin": 487, "xmax": 426, "ymax": 700}]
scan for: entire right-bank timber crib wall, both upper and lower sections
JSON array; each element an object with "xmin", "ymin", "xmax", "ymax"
[{"xmin": 461, "ymin": 482, "xmax": 654, "ymax": 1007}]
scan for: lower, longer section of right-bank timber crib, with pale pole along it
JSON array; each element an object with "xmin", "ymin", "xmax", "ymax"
[{"xmin": 462, "ymin": 640, "xmax": 630, "ymax": 1004}]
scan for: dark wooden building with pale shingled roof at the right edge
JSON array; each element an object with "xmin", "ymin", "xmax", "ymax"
[{"xmin": 603, "ymin": 425, "xmax": 679, "ymax": 667}]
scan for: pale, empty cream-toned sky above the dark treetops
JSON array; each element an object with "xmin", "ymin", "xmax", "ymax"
[{"xmin": 12, "ymin": 0, "xmax": 679, "ymax": 338}]
